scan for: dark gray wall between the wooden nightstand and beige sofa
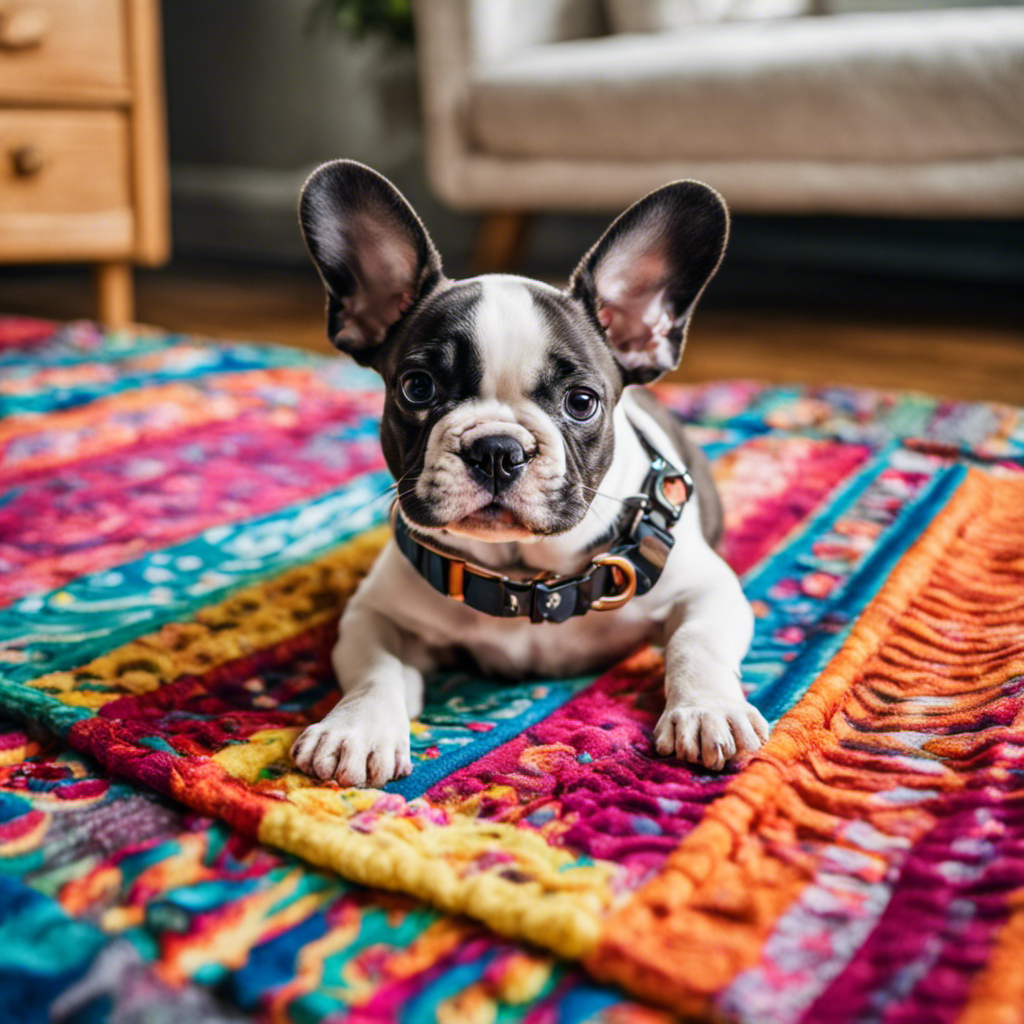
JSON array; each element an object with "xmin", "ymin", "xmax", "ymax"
[{"xmin": 163, "ymin": 0, "xmax": 473, "ymax": 261}]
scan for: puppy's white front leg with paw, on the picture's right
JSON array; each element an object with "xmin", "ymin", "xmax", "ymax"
[{"xmin": 654, "ymin": 550, "xmax": 768, "ymax": 769}]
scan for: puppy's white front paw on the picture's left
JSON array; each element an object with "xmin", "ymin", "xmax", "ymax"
[{"xmin": 292, "ymin": 696, "xmax": 413, "ymax": 786}]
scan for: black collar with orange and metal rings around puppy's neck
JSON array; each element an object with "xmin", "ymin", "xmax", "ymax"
[{"xmin": 392, "ymin": 427, "xmax": 693, "ymax": 623}]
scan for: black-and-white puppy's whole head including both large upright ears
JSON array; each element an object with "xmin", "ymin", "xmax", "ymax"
[{"xmin": 300, "ymin": 160, "xmax": 728, "ymax": 542}]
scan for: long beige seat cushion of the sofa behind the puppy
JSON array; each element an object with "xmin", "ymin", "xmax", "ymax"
[{"xmin": 468, "ymin": 7, "xmax": 1024, "ymax": 162}]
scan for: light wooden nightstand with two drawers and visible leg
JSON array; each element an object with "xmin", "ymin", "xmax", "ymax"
[{"xmin": 0, "ymin": 0, "xmax": 170, "ymax": 326}]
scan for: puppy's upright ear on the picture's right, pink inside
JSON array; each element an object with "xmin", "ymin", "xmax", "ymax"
[{"xmin": 569, "ymin": 181, "xmax": 729, "ymax": 384}]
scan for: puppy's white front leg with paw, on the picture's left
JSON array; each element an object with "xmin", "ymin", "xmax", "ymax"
[{"xmin": 292, "ymin": 605, "xmax": 423, "ymax": 786}]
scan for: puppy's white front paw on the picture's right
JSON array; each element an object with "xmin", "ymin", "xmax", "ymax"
[{"xmin": 654, "ymin": 698, "xmax": 768, "ymax": 771}]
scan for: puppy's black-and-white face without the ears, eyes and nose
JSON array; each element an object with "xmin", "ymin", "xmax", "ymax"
[{"xmin": 381, "ymin": 275, "xmax": 622, "ymax": 541}]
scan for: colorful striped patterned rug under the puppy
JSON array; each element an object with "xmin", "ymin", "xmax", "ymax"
[{"xmin": 0, "ymin": 321, "xmax": 1024, "ymax": 1024}]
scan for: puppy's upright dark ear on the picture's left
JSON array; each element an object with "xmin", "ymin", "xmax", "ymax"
[{"xmin": 299, "ymin": 160, "xmax": 441, "ymax": 366}]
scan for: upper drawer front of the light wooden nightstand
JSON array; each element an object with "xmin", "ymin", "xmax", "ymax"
[{"xmin": 0, "ymin": 0, "xmax": 129, "ymax": 103}]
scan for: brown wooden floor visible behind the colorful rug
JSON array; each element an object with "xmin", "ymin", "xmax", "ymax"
[{"xmin": 6, "ymin": 265, "xmax": 1024, "ymax": 406}]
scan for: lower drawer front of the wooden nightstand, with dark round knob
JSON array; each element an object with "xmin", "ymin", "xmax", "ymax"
[{"xmin": 0, "ymin": 110, "xmax": 132, "ymax": 262}]
